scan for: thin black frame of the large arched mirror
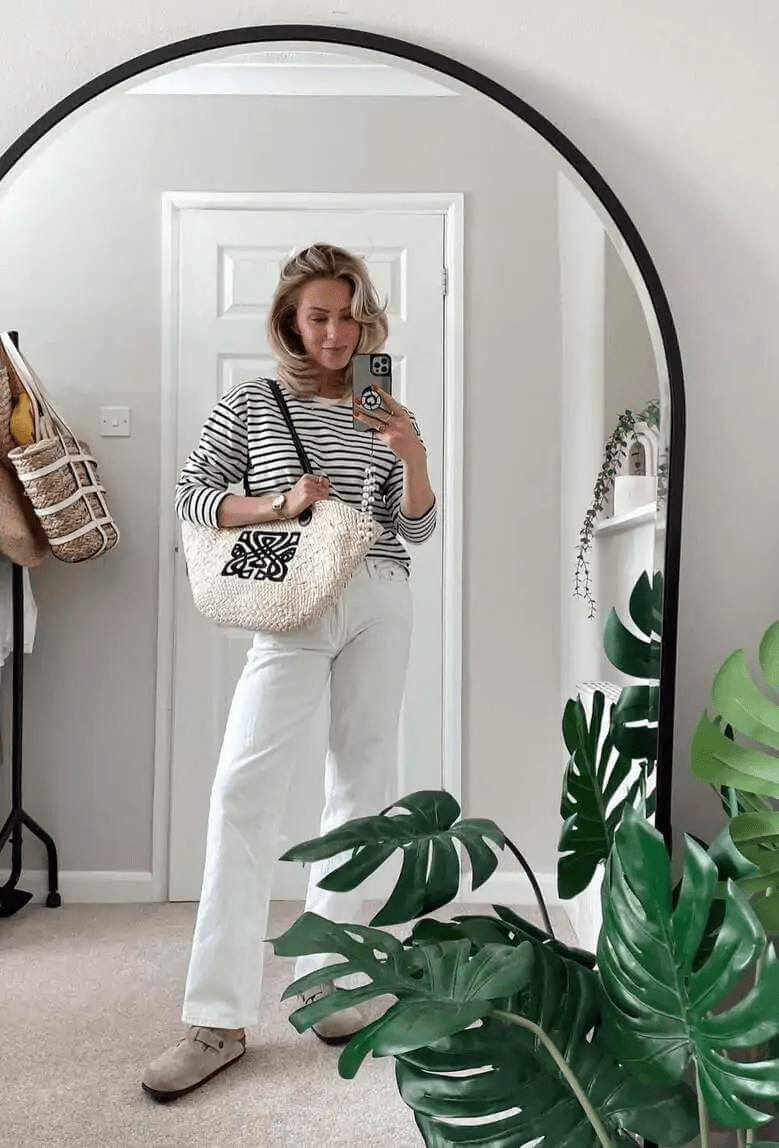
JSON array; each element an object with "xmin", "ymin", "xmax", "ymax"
[{"xmin": 0, "ymin": 24, "xmax": 686, "ymax": 852}]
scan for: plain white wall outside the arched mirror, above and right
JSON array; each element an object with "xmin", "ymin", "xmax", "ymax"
[{"xmin": 0, "ymin": 0, "xmax": 779, "ymax": 877}]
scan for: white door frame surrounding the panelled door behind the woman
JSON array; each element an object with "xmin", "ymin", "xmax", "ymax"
[{"xmin": 151, "ymin": 192, "xmax": 465, "ymax": 901}]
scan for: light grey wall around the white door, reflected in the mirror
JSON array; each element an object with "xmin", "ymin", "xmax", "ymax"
[{"xmin": 0, "ymin": 89, "xmax": 573, "ymax": 871}]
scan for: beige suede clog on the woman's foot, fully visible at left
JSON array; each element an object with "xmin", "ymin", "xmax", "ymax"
[{"xmin": 141, "ymin": 1025, "xmax": 247, "ymax": 1100}]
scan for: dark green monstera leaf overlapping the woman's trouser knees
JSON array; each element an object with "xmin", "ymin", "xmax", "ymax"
[{"xmin": 281, "ymin": 790, "xmax": 506, "ymax": 925}]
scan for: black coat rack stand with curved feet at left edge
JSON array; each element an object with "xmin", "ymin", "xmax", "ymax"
[{"xmin": 0, "ymin": 331, "xmax": 62, "ymax": 917}]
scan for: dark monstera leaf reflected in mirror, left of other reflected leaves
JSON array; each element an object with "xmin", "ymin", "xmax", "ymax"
[{"xmin": 558, "ymin": 690, "xmax": 641, "ymax": 899}]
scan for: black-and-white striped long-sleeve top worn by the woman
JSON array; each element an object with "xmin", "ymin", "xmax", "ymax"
[{"xmin": 174, "ymin": 379, "xmax": 437, "ymax": 569}]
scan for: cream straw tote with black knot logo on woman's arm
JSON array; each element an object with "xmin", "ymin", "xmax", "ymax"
[{"xmin": 181, "ymin": 382, "xmax": 383, "ymax": 633}]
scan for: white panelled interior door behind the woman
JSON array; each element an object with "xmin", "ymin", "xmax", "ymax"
[{"xmin": 169, "ymin": 208, "xmax": 445, "ymax": 901}]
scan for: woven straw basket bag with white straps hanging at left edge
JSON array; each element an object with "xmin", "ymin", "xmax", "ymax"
[{"xmin": 0, "ymin": 332, "xmax": 119, "ymax": 563}]
